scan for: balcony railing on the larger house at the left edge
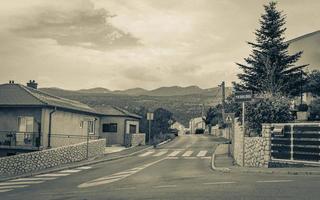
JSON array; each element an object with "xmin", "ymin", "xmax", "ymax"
[{"xmin": 0, "ymin": 131, "xmax": 41, "ymax": 149}]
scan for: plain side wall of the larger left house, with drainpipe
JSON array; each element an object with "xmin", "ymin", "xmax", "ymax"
[{"xmin": 42, "ymin": 108, "xmax": 100, "ymax": 147}]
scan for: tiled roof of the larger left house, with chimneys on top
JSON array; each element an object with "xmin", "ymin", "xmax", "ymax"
[{"xmin": 0, "ymin": 83, "xmax": 100, "ymax": 114}]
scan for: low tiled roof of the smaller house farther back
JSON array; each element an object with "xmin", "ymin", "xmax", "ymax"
[{"xmin": 96, "ymin": 105, "xmax": 141, "ymax": 119}]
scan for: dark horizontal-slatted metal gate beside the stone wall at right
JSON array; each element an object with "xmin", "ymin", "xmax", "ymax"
[{"xmin": 271, "ymin": 123, "xmax": 320, "ymax": 164}]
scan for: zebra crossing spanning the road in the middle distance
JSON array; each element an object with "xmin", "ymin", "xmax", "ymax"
[{"xmin": 138, "ymin": 149, "xmax": 211, "ymax": 159}]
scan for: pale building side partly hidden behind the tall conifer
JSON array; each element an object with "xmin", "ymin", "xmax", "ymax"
[{"xmin": 288, "ymin": 30, "xmax": 320, "ymax": 71}]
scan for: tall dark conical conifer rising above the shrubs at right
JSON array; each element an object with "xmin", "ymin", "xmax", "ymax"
[{"xmin": 235, "ymin": 2, "xmax": 307, "ymax": 96}]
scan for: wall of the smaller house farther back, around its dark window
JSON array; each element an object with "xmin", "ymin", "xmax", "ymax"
[{"xmin": 100, "ymin": 116, "xmax": 139, "ymax": 145}]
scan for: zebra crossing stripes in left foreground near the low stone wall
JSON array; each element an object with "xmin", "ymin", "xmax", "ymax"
[{"xmin": 0, "ymin": 166, "xmax": 92, "ymax": 193}]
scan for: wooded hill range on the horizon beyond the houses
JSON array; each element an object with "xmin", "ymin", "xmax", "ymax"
[{"xmin": 40, "ymin": 86, "xmax": 231, "ymax": 126}]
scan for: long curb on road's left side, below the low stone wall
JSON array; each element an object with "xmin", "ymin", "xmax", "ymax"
[{"xmin": 0, "ymin": 139, "xmax": 171, "ymax": 182}]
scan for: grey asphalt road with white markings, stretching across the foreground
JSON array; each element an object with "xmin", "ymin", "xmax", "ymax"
[{"xmin": 0, "ymin": 135, "xmax": 320, "ymax": 200}]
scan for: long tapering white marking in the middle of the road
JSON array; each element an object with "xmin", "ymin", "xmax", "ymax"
[{"xmin": 78, "ymin": 158, "xmax": 166, "ymax": 188}]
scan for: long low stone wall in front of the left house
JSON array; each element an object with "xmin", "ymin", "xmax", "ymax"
[{"xmin": 0, "ymin": 139, "xmax": 106, "ymax": 177}]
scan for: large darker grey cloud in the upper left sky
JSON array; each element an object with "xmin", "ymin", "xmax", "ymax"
[{"xmin": 11, "ymin": 0, "xmax": 141, "ymax": 50}]
